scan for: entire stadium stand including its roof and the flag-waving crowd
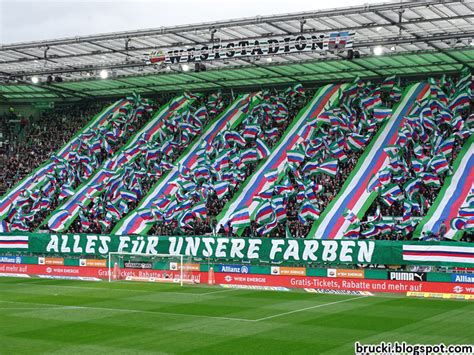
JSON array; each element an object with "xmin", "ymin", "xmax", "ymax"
[{"xmin": 0, "ymin": 0, "xmax": 474, "ymax": 280}]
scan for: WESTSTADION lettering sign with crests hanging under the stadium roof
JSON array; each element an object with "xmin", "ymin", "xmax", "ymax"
[{"xmin": 147, "ymin": 32, "xmax": 354, "ymax": 64}]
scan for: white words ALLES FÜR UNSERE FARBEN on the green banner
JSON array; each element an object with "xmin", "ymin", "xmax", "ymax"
[{"xmin": 42, "ymin": 234, "xmax": 375, "ymax": 263}]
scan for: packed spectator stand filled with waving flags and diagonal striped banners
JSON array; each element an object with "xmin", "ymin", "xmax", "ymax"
[{"xmin": 0, "ymin": 73, "xmax": 474, "ymax": 240}]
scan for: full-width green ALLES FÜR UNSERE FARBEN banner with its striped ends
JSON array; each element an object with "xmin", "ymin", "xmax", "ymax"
[{"xmin": 4, "ymin": 233, "xmax": 474, "ymax": 268}]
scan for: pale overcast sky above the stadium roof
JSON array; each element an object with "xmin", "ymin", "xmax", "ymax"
[{"xmin": 0, "ymin": 0, "xmax": 383, "ymax": 44}]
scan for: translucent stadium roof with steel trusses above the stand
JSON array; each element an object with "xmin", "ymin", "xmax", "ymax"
[{"xmin": 0, "ymin": 0, "xmax": 474, "ymax": 101}]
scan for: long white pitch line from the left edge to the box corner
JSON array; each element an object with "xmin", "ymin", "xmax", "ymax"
[{"xmin": 0, "ymin": 300, "xmax": 256, "ymax": 323}]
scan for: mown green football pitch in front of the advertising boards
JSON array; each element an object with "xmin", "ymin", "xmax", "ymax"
[{"xmin": 0, "ymin": 278, "xmax": 474, "ymax": 354}]
